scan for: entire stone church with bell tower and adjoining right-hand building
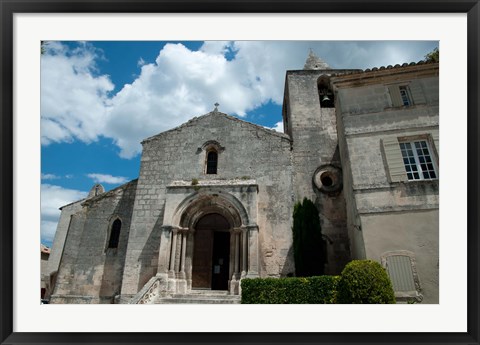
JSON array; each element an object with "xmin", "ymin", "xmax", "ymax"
[{"xmin": 45, "ymin": 53, "xmax": 439, "ymax": 303}]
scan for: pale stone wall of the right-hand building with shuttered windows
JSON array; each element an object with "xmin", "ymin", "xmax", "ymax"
[{"xmin": 333, "ymin": 64, "xmax": 439, "ymax": 303}]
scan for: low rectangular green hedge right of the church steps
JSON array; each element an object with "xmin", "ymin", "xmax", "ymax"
[{"xmin": 241, "ymin": 276, "xmax": 339, "ymax": 304}]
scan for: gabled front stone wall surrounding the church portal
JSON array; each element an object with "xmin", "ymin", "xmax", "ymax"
[{"xmin": 122, "ymin": 111, "xmax": 294, "ymax": 298}]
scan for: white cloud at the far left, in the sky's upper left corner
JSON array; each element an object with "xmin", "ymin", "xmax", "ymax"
[{"xmin": 41, "ymin": 42, "xmax": 114, "ymax": 145}]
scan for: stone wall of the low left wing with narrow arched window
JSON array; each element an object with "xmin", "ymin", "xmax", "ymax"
[{"xmin": 51, "ymin": 180, "xmax": 136, "ymax": 303}]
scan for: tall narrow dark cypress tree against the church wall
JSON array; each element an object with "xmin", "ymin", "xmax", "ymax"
[{"xmin": 292, "ymin": 198, "xmax": 327, "ymax": 277}]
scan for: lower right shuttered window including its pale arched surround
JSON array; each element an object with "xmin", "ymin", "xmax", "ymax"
[{"xmin": 381, "ymin": 250, "xmax": 423, "ymax": 302}]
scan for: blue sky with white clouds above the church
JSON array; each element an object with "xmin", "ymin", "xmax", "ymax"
[{"xmin": 41, "ymin": 41, "xmax": 438, "ymax": 246}]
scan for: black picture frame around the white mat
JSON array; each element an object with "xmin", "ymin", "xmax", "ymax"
[{"xmin": 0, "ymin": 0, "xmax": 480, "ymax": 344}]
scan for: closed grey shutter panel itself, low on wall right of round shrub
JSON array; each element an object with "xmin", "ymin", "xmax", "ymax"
[{"xmin": 387, "ymin": 255, "xmax": 416, "ymax": 291}]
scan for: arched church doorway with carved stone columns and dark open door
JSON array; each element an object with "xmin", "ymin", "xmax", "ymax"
[{"xmin": 157, "ymin": 188, "xmax": 258, "ymax": 294}]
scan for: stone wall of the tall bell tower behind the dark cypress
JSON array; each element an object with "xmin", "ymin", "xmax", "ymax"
[{"xmin": 284, "ymin": 70, "xmax": 350, "ymax": 274}]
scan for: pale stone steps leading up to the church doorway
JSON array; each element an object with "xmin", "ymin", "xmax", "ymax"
[{"xmin": 155, "ymin": 290, "xmax": 240, "ymax": 304}]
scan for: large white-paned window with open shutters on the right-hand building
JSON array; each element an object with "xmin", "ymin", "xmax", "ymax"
[{"xmin": 382, "ymin": 131, "xmax": 438, "ymax": 182}]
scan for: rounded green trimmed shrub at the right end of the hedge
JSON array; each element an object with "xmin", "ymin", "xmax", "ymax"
[{"xmin": 337, "ymin": 260, "xmax": 395, "ymax": 304}]
